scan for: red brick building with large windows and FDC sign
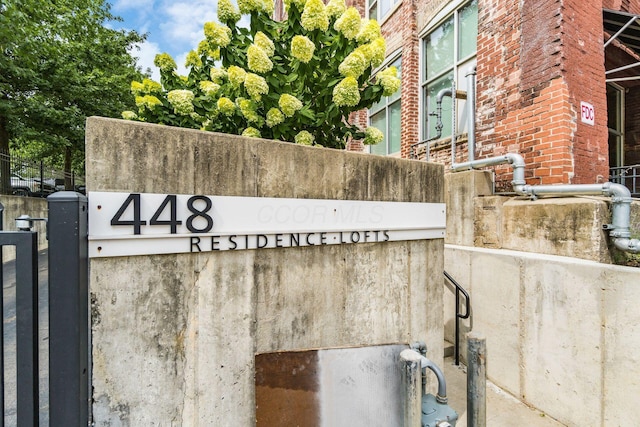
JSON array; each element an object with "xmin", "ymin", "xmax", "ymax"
[{"xmin": 348, "ymin": 0, "xmax": 640, "ymax": 194}]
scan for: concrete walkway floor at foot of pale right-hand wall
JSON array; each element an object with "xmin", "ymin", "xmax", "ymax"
[{"xmin": 442, "ymin": 357, "xmax": 565, "ymax": 427}]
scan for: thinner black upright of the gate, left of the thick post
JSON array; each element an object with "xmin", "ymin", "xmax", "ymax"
[{"xmin": 11, "ymin": 231, "xmax": 40, "ymax": 427}]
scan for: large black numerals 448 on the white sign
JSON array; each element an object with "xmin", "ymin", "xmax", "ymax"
[{"xmin": 111, "ymin": 193, "xmax": 213, "ymax": 234}]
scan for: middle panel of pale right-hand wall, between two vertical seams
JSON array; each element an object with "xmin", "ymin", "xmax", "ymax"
[{"xmin": 512, "ymin": 256, "xmax": 604, "ymax": 425}]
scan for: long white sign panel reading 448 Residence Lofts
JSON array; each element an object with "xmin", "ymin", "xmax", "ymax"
[{"xmin": 89, "ymin": 192, "xmax": 446, "ymax": 257}]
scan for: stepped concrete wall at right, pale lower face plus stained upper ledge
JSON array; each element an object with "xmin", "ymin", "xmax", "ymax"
[{"xmin": 443, "ymin": 171, "xmax": 640, "ymax": 426}]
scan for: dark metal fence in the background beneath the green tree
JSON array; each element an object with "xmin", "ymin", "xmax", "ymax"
[{"xmin": 0, "ymin": 153, "xmax": 84, "ymax": 197}]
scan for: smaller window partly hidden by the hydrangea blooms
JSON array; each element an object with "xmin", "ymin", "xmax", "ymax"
[{"xmin": 369, "ymin": 57, "xmax": 402, "ymax": 155}]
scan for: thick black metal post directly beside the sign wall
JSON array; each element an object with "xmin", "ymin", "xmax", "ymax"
[{"xmin": 47, "ymin": 191, "xmax": 90, "ymax": 427}]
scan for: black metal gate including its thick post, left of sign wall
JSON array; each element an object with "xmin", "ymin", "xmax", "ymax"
[{"xmin": 0, "ymin": 191, "xmax": 91, "ymax": 427}]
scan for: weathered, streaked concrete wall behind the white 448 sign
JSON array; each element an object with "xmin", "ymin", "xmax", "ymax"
[{"xmin": 86, "ymin": 118, "xmax": 444, "ymax": 426}]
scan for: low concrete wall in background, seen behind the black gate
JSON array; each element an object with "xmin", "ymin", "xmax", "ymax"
[{"xmin": 0, "ymin": 195, "xmax": 49, "ymax": 262}]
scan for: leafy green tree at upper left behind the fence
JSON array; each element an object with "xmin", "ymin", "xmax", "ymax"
[{"xmin": 0, "ymin": 0, "xmax": 144, "ymax": 192}]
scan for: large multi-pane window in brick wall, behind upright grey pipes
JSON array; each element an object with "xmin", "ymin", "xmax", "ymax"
[{"xmin": 422, "ymin": 0, "xmax": 478, "ymax": 140}]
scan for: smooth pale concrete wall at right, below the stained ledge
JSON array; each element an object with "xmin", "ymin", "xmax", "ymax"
[{"xmin": 445, "ymin": 245, "xmax": 640, "ymax": 426}]
